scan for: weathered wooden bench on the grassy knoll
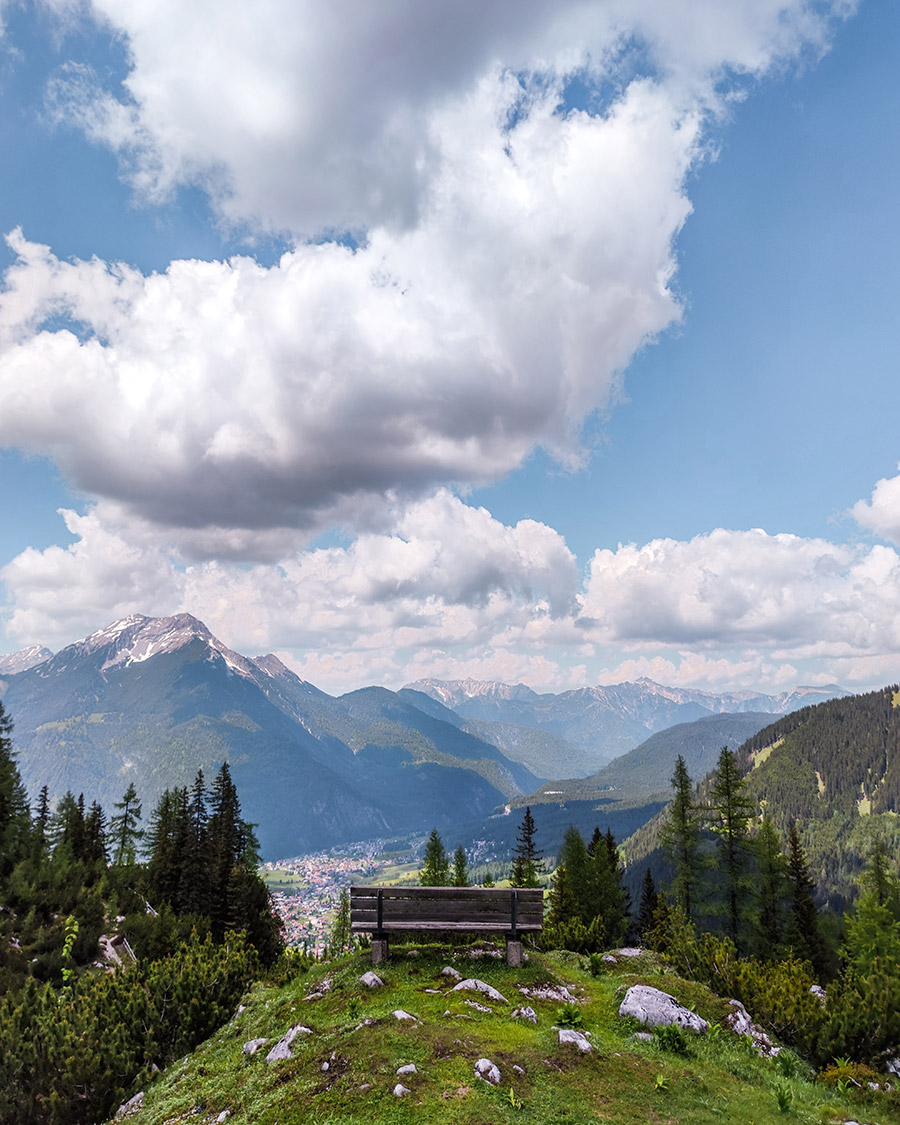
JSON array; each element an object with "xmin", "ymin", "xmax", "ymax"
[{"xmin": 350, "ymin": 887, "xmax": 543, "ymax": 965}]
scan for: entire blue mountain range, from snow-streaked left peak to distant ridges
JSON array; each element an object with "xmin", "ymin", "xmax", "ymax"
[{"xmin": 0, "ymin": 613, "xmax": 840, "ymax": 858}]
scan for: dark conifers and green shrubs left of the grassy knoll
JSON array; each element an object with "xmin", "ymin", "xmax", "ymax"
[{"xmin": 0, "ymin": 703, "xmax": 282, "ymax": 1125}]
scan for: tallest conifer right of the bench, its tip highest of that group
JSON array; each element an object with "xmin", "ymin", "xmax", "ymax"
[{"xmin": 710, "ymin": 746, "xmax": 755, "ymax": 948}]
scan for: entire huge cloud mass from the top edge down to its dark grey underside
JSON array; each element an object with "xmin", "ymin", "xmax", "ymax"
[{"xmin": 0, "ymin": 0, "xmax": 849, "ymax": 540}]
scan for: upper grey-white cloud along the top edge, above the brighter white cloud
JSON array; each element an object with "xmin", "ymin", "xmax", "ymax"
[{"xmin": 52, "ymin": 0, "xmax": 854, "ymax": 233}]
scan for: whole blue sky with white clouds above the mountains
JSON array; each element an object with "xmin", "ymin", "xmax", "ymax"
[{"xmin": 0, "ymin": 0, "xmax": 900, "ymax": 693}]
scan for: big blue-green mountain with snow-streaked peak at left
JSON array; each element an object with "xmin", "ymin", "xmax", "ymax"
[{"xmin": 0, "ymin": 614, "xmax": 538, "ymax": 857}]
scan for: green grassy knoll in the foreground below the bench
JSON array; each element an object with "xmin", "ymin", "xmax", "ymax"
[{"xmin": 107, "ymin": 946, "xmax": 900, "ymax": 1125}]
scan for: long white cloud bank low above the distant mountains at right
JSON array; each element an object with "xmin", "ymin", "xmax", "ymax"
[{"xmin": 584, "ymin": 529, "xmax": 900, "ymax": 658}]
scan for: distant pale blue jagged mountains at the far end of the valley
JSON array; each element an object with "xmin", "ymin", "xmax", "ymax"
[{"xmin": 406, "ymin": 678, "xmax": 846, "ymax": 770}]
